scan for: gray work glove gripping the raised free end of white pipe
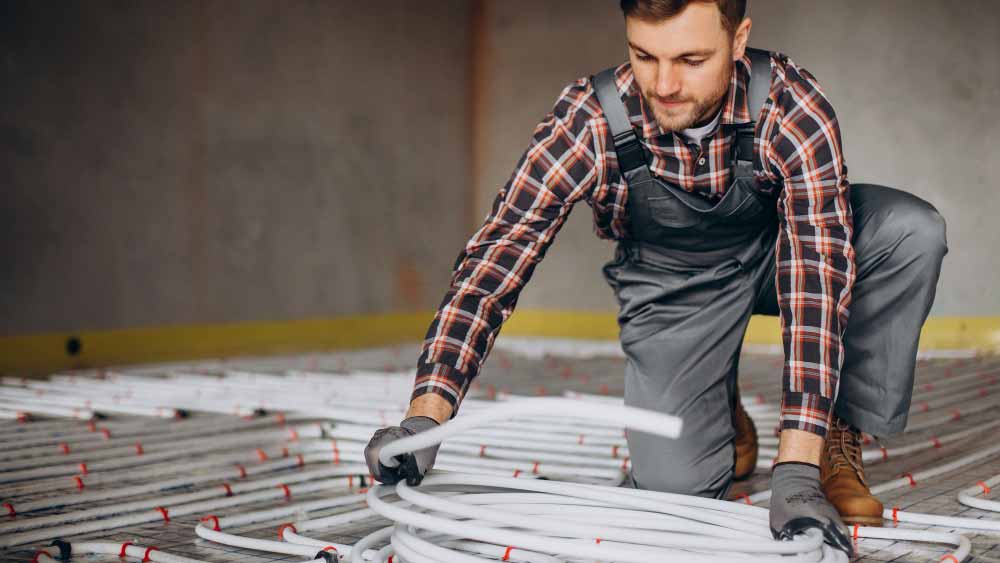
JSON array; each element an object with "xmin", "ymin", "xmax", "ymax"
[{"xmin": 365, "ymin": 416, "xmax": 440, "ymax": 486}]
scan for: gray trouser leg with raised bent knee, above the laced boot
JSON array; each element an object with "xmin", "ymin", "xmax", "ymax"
[{"xmin": 757, "ymin": 184, "xmax": 948, "ymax": 436}]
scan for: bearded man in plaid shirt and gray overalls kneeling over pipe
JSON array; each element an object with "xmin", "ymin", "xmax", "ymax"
[{"xmin": 366, "ymin": 0, "xmax": 947, "ymax": 552}]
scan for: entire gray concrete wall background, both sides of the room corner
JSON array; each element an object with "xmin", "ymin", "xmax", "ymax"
[{"xmin": 0, "ymin": 0, "xmax": 1000, "ymax": 340}]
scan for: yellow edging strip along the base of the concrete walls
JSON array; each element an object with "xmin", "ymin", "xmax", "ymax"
[{"xmin": 0, "ymin": 309, "xmax": 1000, "ymax": 375}]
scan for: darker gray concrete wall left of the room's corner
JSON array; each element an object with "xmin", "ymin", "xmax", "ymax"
[{"xmin": 0, "ymin": 0, "xmax": 471, "ymax": 334}]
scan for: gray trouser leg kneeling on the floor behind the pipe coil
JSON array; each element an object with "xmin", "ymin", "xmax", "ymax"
[{"xmin": 605, "ymin": 245, "xmax": 766, "ymax": 498}]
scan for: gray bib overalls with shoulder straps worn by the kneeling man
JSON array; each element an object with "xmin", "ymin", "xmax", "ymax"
[{"xmin": 592, "ymin": 49, "xmax": 947, "ymax": 497}]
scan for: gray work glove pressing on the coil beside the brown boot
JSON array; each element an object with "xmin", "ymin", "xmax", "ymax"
[{"xmin": 770, "ymin": 461, "xmax": 854, "ymax": 556}]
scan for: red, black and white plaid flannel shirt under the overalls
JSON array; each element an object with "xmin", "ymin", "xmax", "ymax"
[{"xmin": 412, "ymin": 53, "xmax": 855, "ymax": 436}]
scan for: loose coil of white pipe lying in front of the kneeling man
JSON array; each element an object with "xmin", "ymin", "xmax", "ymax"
[{"xmin": 367, "ymin": 474, "xmax": 847, "ymax": 563}]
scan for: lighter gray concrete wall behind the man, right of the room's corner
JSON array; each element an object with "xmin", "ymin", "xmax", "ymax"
[{"xmin": 476, "ymin": 0, "xmax": 1000, "ymax": 315}]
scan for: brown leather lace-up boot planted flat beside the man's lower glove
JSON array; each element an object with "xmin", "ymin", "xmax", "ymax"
[{"xmin": 819, "ymin": 417, "xmax": 882, "ymax": 526}]
